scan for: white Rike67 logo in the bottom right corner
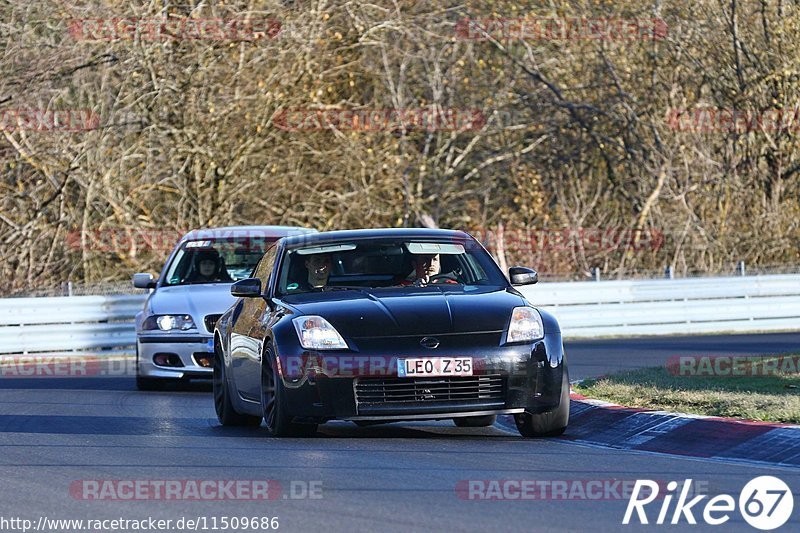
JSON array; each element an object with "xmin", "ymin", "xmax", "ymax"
[{"xmin": 622, "ymin": 476, "xmax": 794, "ymax": 531}]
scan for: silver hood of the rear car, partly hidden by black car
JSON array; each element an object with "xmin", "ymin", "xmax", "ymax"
[{"xmin": 150, "ymin": 283, "xmax": 236, "ymax": 320}]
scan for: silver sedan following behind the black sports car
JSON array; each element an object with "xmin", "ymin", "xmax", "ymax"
[{"xmin": 133, "ymin": 226, "xmax": 315, "ymax": 390}]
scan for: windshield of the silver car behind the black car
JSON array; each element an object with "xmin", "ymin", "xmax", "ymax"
[{"xmin": 164, "ymin": 237, "xmax": 275, "ymax": 285}]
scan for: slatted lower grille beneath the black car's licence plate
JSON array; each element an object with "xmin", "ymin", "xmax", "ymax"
[{"xmin": 355, "ymin": 375, "xmax": 505, "ymax": 407}]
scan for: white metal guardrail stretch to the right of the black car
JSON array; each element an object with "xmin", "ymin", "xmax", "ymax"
[{"xmin": 521, "ymin": 274, "xmax": 800, "ymax": 338}]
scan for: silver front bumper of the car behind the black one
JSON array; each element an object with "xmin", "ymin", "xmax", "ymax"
[{"xmin": 136, "ymin": 333, "xmax": 214, "ymax": 379}]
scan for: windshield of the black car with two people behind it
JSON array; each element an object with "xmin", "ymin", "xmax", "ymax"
[{"xmin": 278, "ymin": 239, "xmax": 507, "ymax": 295}]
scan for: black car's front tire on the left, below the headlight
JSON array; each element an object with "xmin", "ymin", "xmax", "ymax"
[{"xmin": 261, "ymin": 347, "xmax": 317, "ymax": 437}]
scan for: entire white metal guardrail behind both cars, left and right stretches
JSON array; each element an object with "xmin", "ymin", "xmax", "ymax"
[{"xmin": 0, "ymin": 275, "xmax": 800, "ymax": 354}]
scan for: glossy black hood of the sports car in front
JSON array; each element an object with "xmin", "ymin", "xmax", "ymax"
[{"xmin": 283, "ymin": 286, "xmax": 525, "ymax": 338}]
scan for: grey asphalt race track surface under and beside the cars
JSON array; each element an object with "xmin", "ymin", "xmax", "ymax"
[{"xmin": 0, "ymin": 334, "xmax": 800, "ymax": 532}]
